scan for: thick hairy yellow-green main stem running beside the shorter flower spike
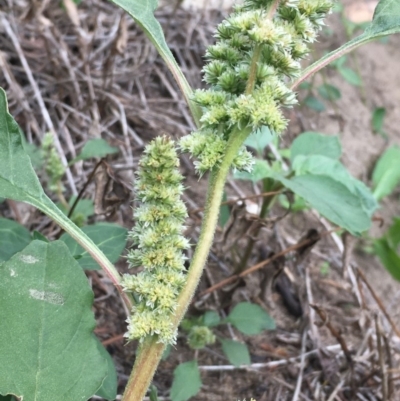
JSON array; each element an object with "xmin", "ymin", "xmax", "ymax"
[{"xmin": 122, "ymin": 128, "xmax": 251, "ymax": 401}]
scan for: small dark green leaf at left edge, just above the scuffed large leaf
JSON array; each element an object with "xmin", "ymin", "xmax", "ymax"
[{"xmin": 0, "ymin": 217, "xmax": 32, "ymax": 262}]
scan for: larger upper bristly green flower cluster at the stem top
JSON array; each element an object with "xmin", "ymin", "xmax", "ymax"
[{"xmin": 180, "ymin": 0, "xmax": 332, "ymax": 174}]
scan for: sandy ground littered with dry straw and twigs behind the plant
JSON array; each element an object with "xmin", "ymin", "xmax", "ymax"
[{"xmin": 0, "ymin": 0, "xmax": 400, "ymax": 401}]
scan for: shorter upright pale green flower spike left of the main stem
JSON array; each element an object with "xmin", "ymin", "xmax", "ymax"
[{"xmin": 122, "ymin": 137, "xmax": 189, "ymax": 344}]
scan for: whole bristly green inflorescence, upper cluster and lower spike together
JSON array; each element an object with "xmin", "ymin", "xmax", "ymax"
[{"xmin": 123, "ymin": 0, "xmax": 332, "ymax": 343}]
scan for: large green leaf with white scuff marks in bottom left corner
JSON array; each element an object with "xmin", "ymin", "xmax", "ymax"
[{"xmin": 0, "ymin": 241, "xmax": 107, "ymax": 401}]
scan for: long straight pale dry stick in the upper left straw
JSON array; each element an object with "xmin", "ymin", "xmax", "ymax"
[{"xmin": 0, "ymin": 13, "xmax": 78, "ymax": 195}]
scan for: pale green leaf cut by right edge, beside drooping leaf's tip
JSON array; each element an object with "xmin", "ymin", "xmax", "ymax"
[{"xmin": 372, "ymin": 146, "xmax": 400, "ymax": 200}]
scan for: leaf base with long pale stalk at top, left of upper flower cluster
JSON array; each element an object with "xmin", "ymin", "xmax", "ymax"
[{"xmin": 111, "ymin": 0, "xmax": 201, "ymax": 122}]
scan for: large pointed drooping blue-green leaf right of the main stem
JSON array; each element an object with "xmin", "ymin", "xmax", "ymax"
[{"xmin": 275, "ymin": 174, "xmax": 371, "ymax": 235}]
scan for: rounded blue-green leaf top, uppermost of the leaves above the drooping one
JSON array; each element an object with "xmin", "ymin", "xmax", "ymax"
[{"xmin": 290, "ymin": 131, "xmax": 342, "ymax": 163}]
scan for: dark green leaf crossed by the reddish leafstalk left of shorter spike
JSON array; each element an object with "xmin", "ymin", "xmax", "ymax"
[{"xmin": 60, "ymin": 223, "xmax": 128, "ymax": 270}]
